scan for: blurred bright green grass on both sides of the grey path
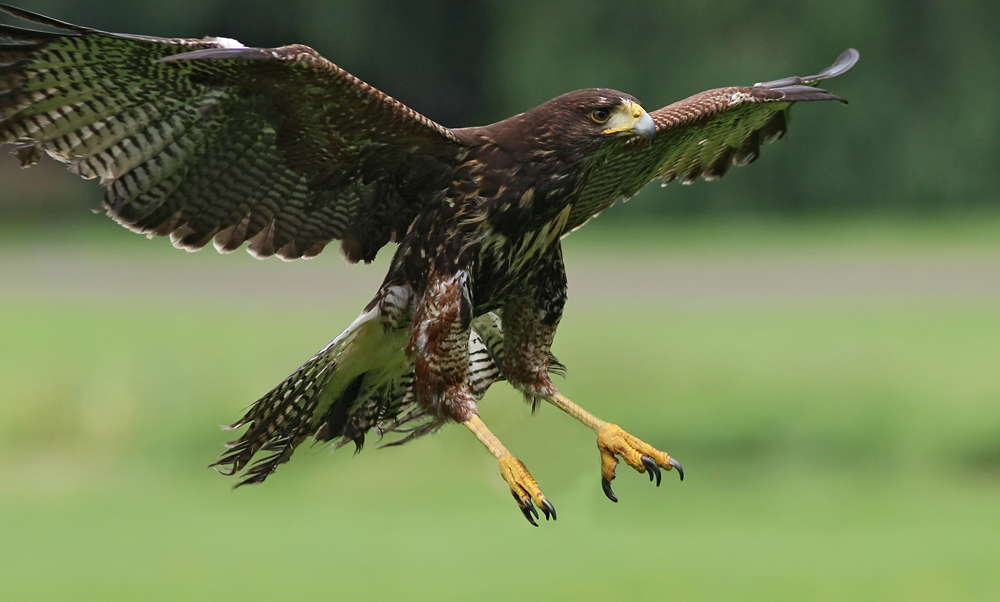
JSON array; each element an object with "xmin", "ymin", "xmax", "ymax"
[{"xmin": 0, "ymin": 218, "xmax": 1000, "ymax": 602}]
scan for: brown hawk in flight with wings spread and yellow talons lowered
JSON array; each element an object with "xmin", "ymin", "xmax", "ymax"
[{"xmin": 0, "ymin": 5, "xmax": 858, "ymax": 524}]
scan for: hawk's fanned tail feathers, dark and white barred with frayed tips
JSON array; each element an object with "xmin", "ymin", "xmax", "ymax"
[{"xmin": 212, "ymin": 308, "xmax": 564, "ymax": 487}]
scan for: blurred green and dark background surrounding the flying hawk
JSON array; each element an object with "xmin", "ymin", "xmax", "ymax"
[{"xmin": 0, "ymin": 0, "xmax": 1000, "ymax": 600}]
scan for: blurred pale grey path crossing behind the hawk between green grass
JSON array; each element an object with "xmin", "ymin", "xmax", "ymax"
[{"xmin": 0, "ymin": 243, "xmax": 1000, "ymax": 308}]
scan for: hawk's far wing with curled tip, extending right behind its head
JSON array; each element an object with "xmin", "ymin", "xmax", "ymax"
[{"xmin": 569, "ymin": 48, "xmax": 859, "ymax": 228}]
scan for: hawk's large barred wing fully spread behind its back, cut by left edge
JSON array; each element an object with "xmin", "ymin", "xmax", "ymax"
[{"xmin": 0, "ymin": 5, "xmax": 464, "ymax": 261}]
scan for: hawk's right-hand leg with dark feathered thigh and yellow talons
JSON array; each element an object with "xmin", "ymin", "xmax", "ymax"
[{"xmin": 503, "ymin": 247, "xmax": 684, "ymax": 502}]
